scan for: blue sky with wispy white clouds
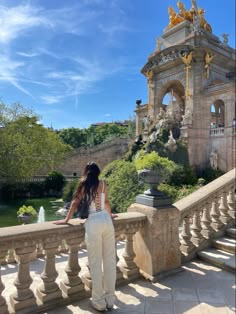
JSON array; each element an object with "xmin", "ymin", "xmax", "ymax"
[{"xmin": 0, "ymin": 0, "xmax": 235, "ymax": 129}]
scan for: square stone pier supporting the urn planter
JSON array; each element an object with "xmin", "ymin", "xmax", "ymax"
[{"xmin": 128, "ymin": 203, "xmax": 181, "ymax": 281}]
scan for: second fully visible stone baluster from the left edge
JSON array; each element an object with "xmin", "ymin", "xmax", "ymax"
[{"xmin": 36, "ymin": 238, "xmax": 62, "ymax": 303}]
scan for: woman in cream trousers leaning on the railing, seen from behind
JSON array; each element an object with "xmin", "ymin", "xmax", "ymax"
[{"xmin": 55, "ymin": 162, "xmax": 117, "ymax": 311}]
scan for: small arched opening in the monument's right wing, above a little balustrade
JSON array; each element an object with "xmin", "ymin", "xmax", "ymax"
[{"xmin": 210, "ymin": 99, "xmax": 225, "ymax": 128}]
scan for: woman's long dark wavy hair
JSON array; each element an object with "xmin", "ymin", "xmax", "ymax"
[{"xmin": 75, "ymin": 162, "xmax": 100, "ymax": 205}]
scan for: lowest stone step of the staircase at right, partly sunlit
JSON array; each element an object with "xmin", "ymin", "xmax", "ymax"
[{"xmin": 197, "ymin": 248, "xmax": 236, "ymax": 273}]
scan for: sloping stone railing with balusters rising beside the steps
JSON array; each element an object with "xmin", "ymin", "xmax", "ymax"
[{"xmin": 173, "ymin": 169, "xmax": 236, "ymax": 261}]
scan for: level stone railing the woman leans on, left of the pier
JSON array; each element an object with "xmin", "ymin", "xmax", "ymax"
[{"xmin": 0, "ymin": 213, "xmax": 146, "ymax": 314}]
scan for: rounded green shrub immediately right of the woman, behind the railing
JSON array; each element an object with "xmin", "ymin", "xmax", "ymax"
[{"xmin": 101, "ymin": 160, "xmax": 143, "ymax": 212}]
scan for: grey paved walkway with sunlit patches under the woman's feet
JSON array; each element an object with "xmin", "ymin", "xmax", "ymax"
[{"xmin": 2, "ymin": 249, "xmax": 236, "ymax": 314}]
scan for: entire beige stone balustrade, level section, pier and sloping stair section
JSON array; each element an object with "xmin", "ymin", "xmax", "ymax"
[{"xmin": 0, "ymin": 169, "xmax": 236, "ymax": 314}]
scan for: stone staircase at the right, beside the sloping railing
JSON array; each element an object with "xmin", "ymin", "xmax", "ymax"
[{"xmin": 198, "ymin": 227, "xmax": 236, "ymax": 273}]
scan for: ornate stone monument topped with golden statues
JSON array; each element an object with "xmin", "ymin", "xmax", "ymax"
[{"xmin": 135, "ymin": 0, "xmax": 236, "ymax": 171}]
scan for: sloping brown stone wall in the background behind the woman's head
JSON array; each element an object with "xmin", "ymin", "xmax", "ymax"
[{"xmin": 57, "ymin": 137, "xmax": 129, "ymax": 176}]
